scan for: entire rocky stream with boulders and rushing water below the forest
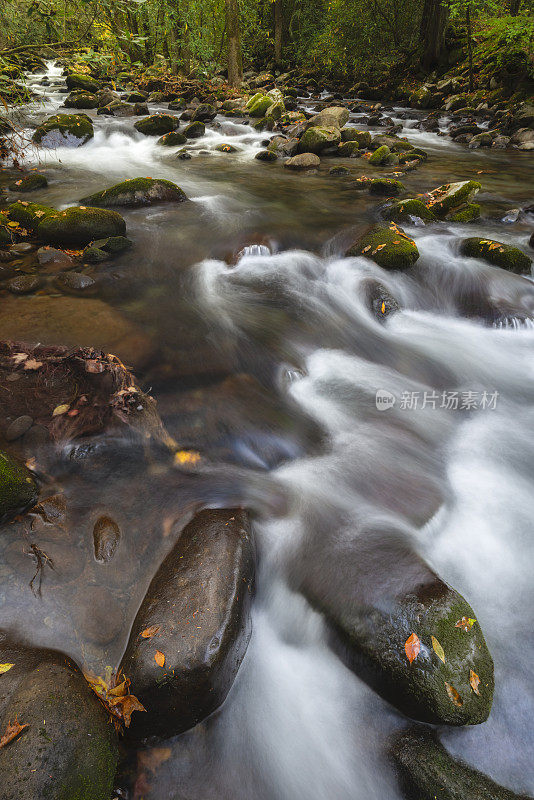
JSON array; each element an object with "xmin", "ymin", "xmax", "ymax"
[{"xmin": 0, "ymin": 64, "xmax": 534, "ymax": 800}]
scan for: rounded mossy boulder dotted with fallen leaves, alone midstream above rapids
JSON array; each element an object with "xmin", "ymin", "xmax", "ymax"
[{"xmin": 346, "ymin": 223, "xmax": 419, "ymax": 270}]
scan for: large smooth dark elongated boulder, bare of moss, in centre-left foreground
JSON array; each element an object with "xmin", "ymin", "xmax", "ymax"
[{"xmin": 121, "ymin": 509, "xmax": 254, "ymax": 738}]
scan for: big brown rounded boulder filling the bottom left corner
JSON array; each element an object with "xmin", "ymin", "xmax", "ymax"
[{"xmin": 0, "ymin": 634, "xmax": 118, "ymax": 800}]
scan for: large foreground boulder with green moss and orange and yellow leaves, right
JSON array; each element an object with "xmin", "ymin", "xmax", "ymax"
[{"xmin": 302, "ymin": 531, "xmax": 494, "ymax": 725}]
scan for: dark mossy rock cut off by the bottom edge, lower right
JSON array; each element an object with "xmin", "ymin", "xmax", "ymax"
[{"xmin": 390, "ymin": 728, "xmax": 529, "ymax": 800}]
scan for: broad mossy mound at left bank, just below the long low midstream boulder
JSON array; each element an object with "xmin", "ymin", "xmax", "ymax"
[{"xmin": 37, "ymin": 206, "xmax": 126, "ymax": 247}]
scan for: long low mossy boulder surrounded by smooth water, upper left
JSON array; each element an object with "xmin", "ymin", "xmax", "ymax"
[{"xmin": 80, "ymin": 178, "xmax": 187, "ymax": 208}]
